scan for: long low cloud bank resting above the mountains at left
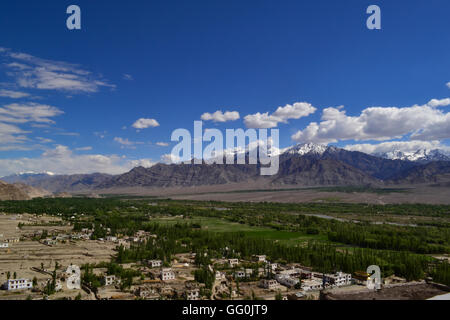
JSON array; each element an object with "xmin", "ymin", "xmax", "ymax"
[{"xmin": 0, "ymin": 145, "xmax": 153, "ymax": 176}]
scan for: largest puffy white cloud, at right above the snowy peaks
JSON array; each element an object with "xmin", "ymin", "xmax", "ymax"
[{"xmin": 292, "ymin": 99, "xmax": 450, "ymax": 143}]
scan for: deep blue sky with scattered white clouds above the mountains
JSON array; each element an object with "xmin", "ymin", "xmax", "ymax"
[{"xmin": 0, "ymin": 0, "xmax": 450, "ymax": 175}]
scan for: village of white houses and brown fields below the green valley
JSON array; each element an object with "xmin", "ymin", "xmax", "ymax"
[{"xmin": 0, "ymin": 214, "xmax": 432, "ymax": 300}]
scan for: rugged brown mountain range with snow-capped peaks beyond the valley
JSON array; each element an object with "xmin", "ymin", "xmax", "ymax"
[{"xmin": 1, "ymin": 143, "xmax": 450, "ymax": 192}]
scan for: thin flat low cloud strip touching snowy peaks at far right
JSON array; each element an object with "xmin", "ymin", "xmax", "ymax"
[{"xmin": 343, "ymin": 140, "xmax": 450, "ymax": 154}]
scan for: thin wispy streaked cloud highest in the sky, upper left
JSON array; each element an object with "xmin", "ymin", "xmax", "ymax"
[{"xmin": 0, "ymin": 48, "xmax": 115, "ymax": 93}]
